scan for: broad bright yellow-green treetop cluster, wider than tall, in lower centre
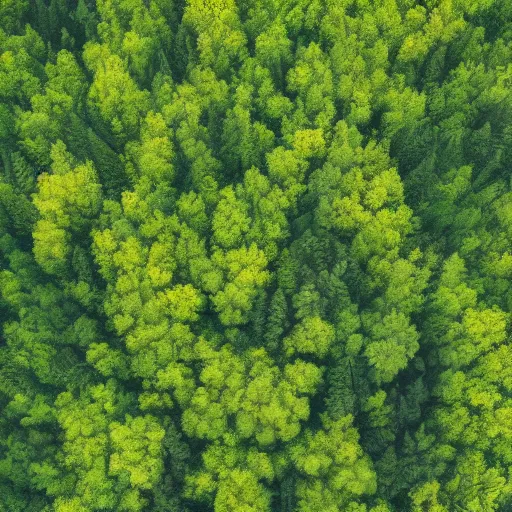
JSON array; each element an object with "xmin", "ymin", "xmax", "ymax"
[{"xmin": 178, "ymin": 345, "xmax": 321, "ymax": 446}]
